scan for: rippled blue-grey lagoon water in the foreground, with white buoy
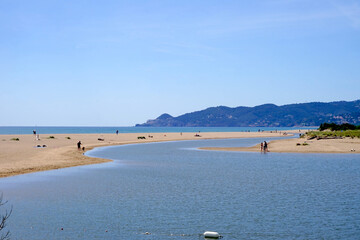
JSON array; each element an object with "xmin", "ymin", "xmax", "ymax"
[{"xmin": 0, "ymin": 139, "xmax": 360, "ymax": 240}]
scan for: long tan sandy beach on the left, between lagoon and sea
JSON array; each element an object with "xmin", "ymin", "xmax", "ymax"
[{"xmin": 0, "ymin": 132, "xmax": 290, "ymax": 177}]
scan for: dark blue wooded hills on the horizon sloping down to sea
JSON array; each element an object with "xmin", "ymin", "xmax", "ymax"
[{"xmin": 136, "ymin": 100, "xmax": 360, "ymax": 127}]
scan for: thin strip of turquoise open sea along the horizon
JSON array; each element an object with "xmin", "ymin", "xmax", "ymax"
[{"xmin": 0, "ymin": 126, "xmax": 314, "ymax": 135}]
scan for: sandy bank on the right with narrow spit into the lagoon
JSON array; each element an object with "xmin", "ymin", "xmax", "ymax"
[{"xmin": 201, "ymin": 138, "xmax": 360, "ymax": 154}]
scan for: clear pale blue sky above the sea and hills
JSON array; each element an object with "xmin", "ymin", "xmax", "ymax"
[{"xmin": 0, "ymin": 0, "xmax": 360, "ymax": 126}]
